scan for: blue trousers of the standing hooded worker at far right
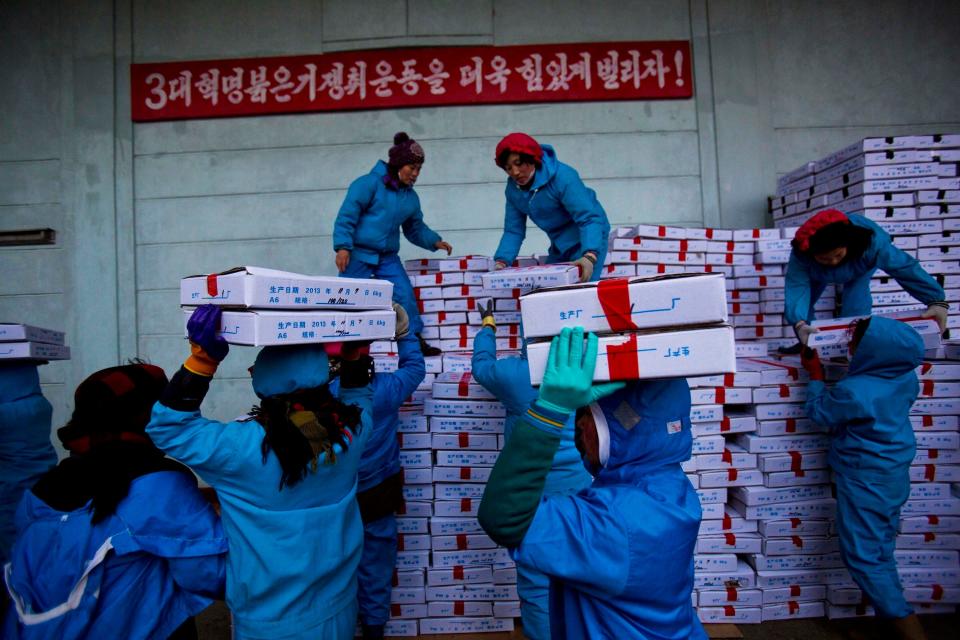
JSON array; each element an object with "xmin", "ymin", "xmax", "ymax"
[{"xmin": 835, "ymin": 468, "xmax": 913, "ymax": 618}]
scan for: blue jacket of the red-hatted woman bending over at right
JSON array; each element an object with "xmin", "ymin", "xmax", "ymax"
[{"xmin": 784, "ymin": 215, "xmax": 945, "ymax": 326}]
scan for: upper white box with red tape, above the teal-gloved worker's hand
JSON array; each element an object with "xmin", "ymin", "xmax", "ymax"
[{"xmin": 520, "ymin": 273, "xmax": 727, "ymax": 338}]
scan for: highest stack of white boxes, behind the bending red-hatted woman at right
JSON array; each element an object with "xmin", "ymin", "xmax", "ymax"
[{"xmin": 770, "ymin": 134, "xmax": 960, "ymax": 340}]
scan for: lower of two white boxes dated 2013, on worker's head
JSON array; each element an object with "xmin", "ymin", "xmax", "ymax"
[{"xmin": 183, "ymin": 308, "xmax": 397, "ymax": 347}]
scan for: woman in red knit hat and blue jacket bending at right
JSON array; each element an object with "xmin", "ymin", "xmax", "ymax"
[{"xmin": 784, "ymin": 209, "xmax": 948, "ymax": 345}]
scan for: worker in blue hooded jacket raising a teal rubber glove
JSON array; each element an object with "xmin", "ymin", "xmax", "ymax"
[{"xmin": 478, "ymin": 327, "xmax": 706, "ymax": 639}]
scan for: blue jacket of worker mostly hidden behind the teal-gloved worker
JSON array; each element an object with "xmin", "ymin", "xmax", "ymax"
[{"xmin": 471, "ymin": 327, "xmax": 591, "ymax": 494}]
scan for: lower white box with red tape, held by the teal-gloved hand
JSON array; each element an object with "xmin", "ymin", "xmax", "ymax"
[{"xmin": 527, "ymin": 324, "xmax": 736, "ymax": 385}]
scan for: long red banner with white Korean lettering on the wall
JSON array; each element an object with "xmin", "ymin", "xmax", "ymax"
[{"xmin": 130, "ymin": 40, "xmax": 693, "ymax": 122}]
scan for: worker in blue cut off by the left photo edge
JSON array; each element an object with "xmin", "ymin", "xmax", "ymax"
[{"xmin": 0, "ymin": 361, "xmax": 57, "ymax": 566}]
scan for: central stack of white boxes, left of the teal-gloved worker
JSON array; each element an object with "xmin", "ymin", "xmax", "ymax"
[{"xmin": 371, "ymin": 256, "xmax": 577, "ymax": 636}]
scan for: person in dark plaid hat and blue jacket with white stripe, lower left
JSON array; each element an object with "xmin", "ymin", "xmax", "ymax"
[{"xmin": 3, "ymin": 364, "xmax": 227, "ymax": 640}]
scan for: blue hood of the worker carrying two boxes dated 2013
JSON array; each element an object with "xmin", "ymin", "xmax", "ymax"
[{"xmin": 253, "ymin": 344, "xmax": 330, "ymax": 398}]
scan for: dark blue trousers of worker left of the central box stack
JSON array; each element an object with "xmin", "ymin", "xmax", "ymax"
[{"xmin": 357, "ymin": 513, "xmax": 397, "ymax": 625}]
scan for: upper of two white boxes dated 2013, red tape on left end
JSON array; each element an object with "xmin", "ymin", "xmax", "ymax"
[{"xmin": 180, "ymin": 267, "xmax": 393, "ymax": 310}]
